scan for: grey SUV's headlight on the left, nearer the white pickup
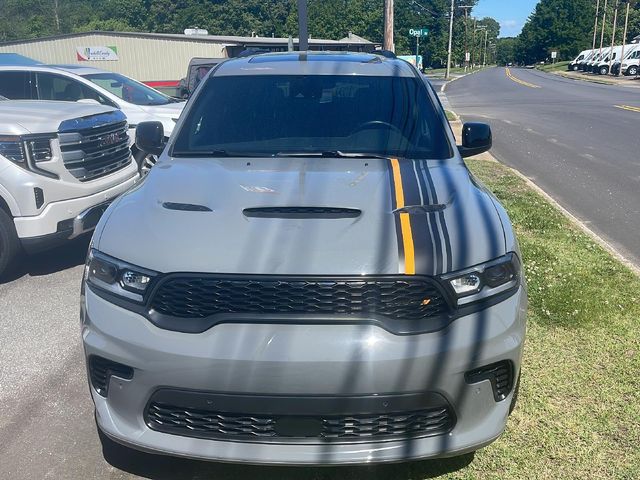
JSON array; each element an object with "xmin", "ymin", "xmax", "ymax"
[{"xmin": 84, "ymin": 249, "xmax": 158, "ymax": 303}]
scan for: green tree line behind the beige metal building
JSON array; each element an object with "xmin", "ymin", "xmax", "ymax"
[{"xmin": 0, "ymin": 0, "xmax": 500, "ymax": 67}]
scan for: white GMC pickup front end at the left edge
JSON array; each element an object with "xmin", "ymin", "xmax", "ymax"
[{"xmin": 0, "ymin": 97, "xmax": 139, "ymax": 276}]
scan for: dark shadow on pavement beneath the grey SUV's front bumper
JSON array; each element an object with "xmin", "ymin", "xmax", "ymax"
[{"xmin": 102, "ymin": 440, "xmax": 474, "ymax": 480}]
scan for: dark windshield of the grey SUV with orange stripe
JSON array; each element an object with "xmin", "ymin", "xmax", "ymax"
[{"xmin": 172, "ymin": 75, "xmax": 452, "ymax": 159}]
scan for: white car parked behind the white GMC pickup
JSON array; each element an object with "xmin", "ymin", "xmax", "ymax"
[{"xmin": 0, "ymin": 65, "xmax": 184, "ymax": 174}]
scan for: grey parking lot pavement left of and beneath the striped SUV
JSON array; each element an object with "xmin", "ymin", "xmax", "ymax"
[{"xmin": 0, "ymin": 238, "xmax": 473, "ymax": 480}]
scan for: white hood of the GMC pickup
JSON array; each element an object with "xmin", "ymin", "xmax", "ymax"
[{"xmin": 0, "ymin": 100, "xmax": 114, "ymax": 135}]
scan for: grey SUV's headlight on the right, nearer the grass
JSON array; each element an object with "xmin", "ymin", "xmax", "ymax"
[{"xmin": 441, "ymin": 253, "xmax": 520, "ymax": 306}]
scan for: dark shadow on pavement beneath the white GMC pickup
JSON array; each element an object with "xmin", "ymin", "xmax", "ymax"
[{"xmin": 0, "ymin": 234, "xmax": 91, "ymax": 285}]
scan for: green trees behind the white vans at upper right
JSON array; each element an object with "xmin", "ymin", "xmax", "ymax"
[{"xmin": 497, "ymin": 0, "xmax": 640, "ymax": 64}]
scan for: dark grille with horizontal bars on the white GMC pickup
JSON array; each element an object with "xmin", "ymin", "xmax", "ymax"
[{"xmin": 58, "ymin": 121, "xmax": 131, "ymax": 182}]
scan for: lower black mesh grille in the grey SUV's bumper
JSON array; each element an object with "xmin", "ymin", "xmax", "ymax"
[{"xmin": 146, "ymin": 402, "xmax": 455, "ymax": 441}]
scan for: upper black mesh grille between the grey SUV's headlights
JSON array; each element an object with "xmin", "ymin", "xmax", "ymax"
[{"xmin": 151, "ymin": 276, "xmax": 448, "ymax": 320}]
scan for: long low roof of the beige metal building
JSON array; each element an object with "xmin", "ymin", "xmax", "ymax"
[{"xmin": 0, "ymin": 30, "xmax": 379, "ymax": 47}]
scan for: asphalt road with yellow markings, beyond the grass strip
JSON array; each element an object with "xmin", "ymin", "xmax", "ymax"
[{"xmin": 446, "ymin": 68, "xmax": 640, "ymax": 265}]
